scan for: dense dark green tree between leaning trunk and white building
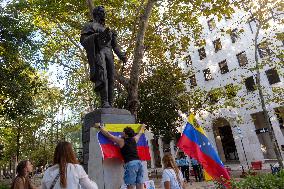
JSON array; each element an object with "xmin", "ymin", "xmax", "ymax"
[{"xmin": 138, "ymin": 63, "xmax": 187, "ymax": 138}]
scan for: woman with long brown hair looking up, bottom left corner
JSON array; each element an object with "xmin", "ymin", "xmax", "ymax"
[{"xmin": 11, "ymin": 160, "xmax": 36, "ymax": 189}]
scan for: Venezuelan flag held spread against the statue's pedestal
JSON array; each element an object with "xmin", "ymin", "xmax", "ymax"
[{"xmin": 98, "ymin": 124, "xmax": 151, "ymax": 161}]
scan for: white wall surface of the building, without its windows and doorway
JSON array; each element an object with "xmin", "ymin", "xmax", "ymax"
[{"xmin": 181, "ymin": 8, "xmax": 284, "ymax": 164}]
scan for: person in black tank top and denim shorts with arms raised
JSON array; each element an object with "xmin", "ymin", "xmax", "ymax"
[{"xmin": 95, "ymin": 124, "xmax": 145, "ymax": 189}]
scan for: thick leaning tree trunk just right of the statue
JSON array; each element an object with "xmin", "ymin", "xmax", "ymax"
[{"xmin": 127, "ymin": 0, "xmax": 157, "ymax": 116}]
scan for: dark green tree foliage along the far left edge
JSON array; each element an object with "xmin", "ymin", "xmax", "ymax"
[{"xmin": 0, "ymin": 2, "xmax": 39, "ymax": 119}]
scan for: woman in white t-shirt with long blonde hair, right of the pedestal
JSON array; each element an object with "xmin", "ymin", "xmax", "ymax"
[{"xmin": 162, "ymin": 154, "xmax": 185, "ymax": 189}]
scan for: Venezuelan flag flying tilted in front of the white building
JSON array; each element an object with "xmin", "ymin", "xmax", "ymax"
[{"xmin": 177, "ymin": 114, "xmax": 230, "ymax": 181}]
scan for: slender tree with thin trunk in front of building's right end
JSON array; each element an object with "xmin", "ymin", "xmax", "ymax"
[{"xmin": 233, "ymin": 0, "xmax": 284, "ymax": 168}]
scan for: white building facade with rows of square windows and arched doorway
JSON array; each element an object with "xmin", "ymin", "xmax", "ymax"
[{"xmin": 181, "ymin": 8, "xmax": 284, "ymax": 165}]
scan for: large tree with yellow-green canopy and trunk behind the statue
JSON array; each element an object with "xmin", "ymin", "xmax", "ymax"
[{"xmin": 7, "ymin": 0, "xmax": 237, "ymax": 114}]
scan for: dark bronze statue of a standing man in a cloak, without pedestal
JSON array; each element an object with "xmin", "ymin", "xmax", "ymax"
[{"xmin": 80, "ymin": 6, "xmax": 127, "ymax": 108}]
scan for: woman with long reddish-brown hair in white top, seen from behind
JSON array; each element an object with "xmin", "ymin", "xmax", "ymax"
[{"xmin": 42, "ymin": 142, "xmax": 98, "ymax": 189}]
